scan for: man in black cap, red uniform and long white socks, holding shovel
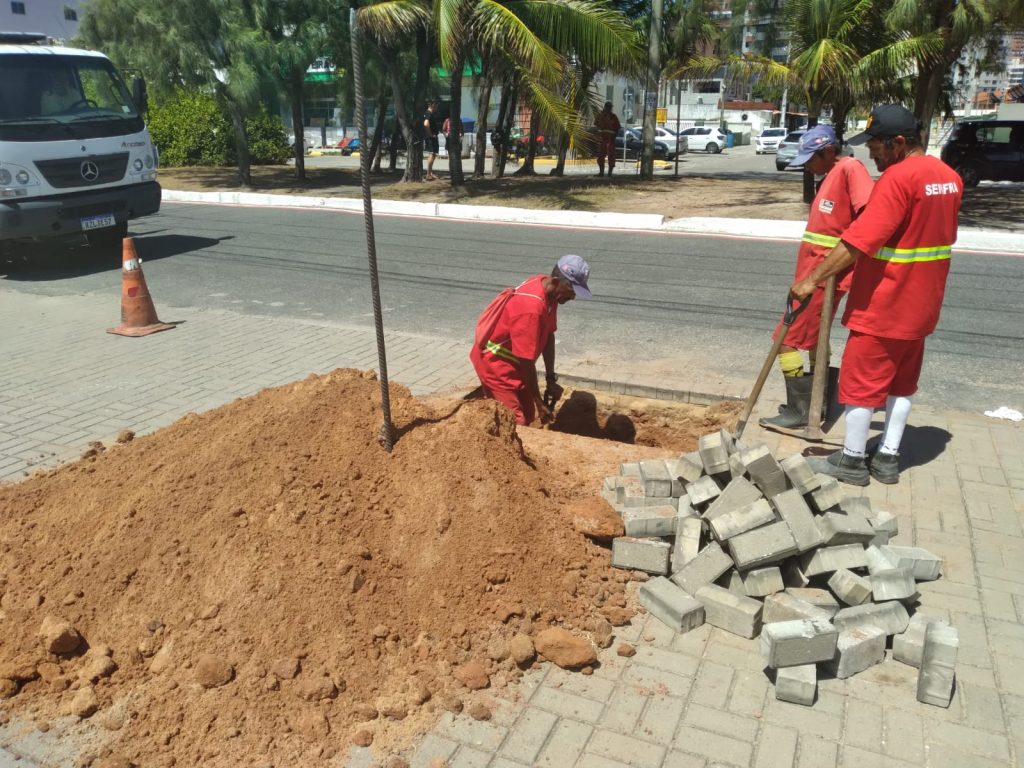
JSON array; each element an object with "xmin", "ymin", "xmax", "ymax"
[{"xmin": 790, "ymin": 104, "xmax": 963, "ymax": 485}]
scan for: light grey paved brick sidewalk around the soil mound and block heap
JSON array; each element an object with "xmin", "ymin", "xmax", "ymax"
[{"xmin": 0, "ymin": 288, "xmax": 1024, "ymax": 768}]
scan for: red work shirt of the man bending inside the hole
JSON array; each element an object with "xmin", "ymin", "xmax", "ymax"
[{"xmin": 474, "ymin": 274, "xmax": 558, "ymax": 389}]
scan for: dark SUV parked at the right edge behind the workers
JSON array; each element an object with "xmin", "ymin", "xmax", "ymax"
[{"xmin": 942, "ymin": 120, "xmax": 1024, "ymax": 186}]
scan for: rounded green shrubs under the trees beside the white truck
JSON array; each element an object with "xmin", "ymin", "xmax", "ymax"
[{"xmin": 146, "ymin": 90, "xmax": 291, "ymax": 167}]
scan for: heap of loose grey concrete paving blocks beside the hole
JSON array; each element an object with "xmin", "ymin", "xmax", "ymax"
[{"xmin": 603, "ymin": 430, "xmax": 958, "ymax": 707}]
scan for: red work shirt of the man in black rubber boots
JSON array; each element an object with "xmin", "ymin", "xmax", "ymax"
[{"xmin": 796, "ymin": 158, "xmax": 874, "ymax": 292}]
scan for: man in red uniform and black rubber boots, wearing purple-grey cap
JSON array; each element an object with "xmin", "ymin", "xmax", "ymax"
[{"xmin": 759, "ymin": 125, "xmax": 874, "ymax": 429}]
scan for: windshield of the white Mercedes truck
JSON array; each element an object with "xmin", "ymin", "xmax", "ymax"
[{"xmin": 0, "ymin": 53, "xmax": 143, "ymax": 141}]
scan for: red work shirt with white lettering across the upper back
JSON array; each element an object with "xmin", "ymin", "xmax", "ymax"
[{"xmin": 843, "ymin": 155, "xmax": 964, "ymax": 341}]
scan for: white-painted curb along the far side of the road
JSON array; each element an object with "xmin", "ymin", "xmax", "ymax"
[{"xmin": 163, "ymin": 189, "xmax": 1024, "ymax": 256}]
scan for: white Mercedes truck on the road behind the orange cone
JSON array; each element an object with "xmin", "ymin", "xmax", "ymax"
[{"xmin": 0, "ymin": 33, "xmax": 161, "ymax": 252}]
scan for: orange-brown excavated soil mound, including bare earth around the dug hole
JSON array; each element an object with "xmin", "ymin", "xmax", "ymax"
[{"xmin": 0, "ymin": 370, "xmax": 738, "ymax": 768}]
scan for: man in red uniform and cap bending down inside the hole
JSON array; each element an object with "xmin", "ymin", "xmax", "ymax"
[{"xmin": 469, "ymin": 254, "xmax": 591, "ymax": 425}]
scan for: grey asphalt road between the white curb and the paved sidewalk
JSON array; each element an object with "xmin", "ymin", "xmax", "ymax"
[{"xmin": 0, "ymin": 204, "xmax": 1024, "ymax": 412}]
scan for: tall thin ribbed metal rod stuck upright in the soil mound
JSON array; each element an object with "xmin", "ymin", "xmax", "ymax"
[{"xmin": 348, "ymin": 0, "xmax": 394, "ymax": 454}]
